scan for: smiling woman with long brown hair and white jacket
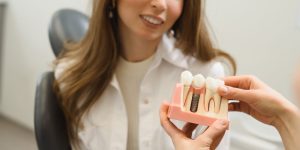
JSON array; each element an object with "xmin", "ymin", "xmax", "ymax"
[{"xmin": 55, "ymin": 0, "xmax": 234, "ymax": 149}]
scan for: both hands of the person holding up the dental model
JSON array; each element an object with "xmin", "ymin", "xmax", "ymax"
[{"xmin": 160, "ymin": 76, "xmax": 300, "ymax": 150}]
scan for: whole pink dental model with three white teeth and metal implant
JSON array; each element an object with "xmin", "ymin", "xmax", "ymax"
[{"xmin": 168, "ymin": 71, "xmax": 228, "ymax": 126}]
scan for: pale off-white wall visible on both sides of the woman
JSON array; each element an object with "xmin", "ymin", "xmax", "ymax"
[{"xmin": 0, "ymin": 0, "xmax": 300, "ymax": 146}]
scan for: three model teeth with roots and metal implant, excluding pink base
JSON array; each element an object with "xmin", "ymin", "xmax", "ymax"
[{"xmin": 181, "ymin": 71, "xmax": 224, "ymax": 113}]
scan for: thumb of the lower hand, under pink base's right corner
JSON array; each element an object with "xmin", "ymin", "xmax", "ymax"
[{"xmin": 196, "ymin": 119, "xmax": 228, "ymax": 142}]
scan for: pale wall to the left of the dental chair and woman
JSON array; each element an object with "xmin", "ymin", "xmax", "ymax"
[{"xmin": 0, "ymin": 0, "xmax": 88, "ymax": 129}]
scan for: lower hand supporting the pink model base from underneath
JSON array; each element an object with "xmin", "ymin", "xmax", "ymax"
[{"xmin": 160, "ymin": 103, "xmax": 228, "ymax": 150}]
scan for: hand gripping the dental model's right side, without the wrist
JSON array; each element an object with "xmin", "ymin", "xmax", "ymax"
[{"xmin": 218, "ymin": 76, "xmax": 295, "ymax": 125}]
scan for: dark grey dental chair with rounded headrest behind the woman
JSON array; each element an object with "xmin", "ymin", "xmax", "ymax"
[{"xmin": 34, "ymin": 9, "xmax": 89, "ymax": 150}]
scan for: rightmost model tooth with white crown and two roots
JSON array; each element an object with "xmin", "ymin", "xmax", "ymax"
[{"xmin": 204, "ymin": 77, "xmax": 224, "ymax": 113}]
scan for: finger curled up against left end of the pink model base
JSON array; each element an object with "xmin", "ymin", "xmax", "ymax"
[{"xmin": 160, "ymin": 103, "xmax": 184, "ymax": 138}]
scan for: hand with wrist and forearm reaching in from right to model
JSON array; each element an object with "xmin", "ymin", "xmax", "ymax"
[{"xmin": 218, "ymin": 76, "xmax": 300, "ymax": 150}]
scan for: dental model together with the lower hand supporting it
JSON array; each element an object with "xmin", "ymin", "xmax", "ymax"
[{"xmin": 160, "ymin": 71, "xmax": 229, "ymax": 150}]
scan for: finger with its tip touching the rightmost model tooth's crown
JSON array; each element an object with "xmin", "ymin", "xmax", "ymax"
[{"xmin": 218, "ymin": 86, "xmax": 256, "ymax": 104}]
